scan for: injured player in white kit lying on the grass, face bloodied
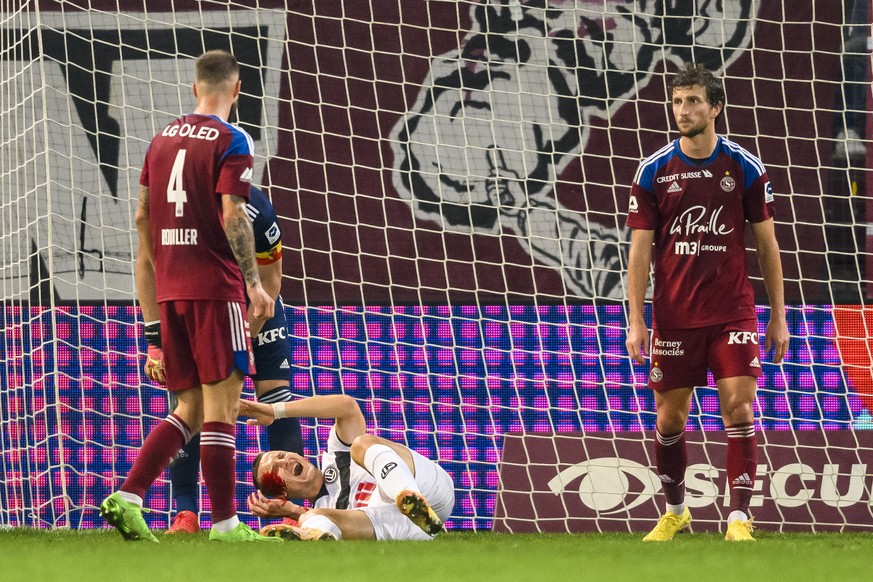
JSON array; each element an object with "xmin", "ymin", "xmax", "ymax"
[{"xmin": 240, "ymin": 395, "xmax": 455, "ymax": 540}]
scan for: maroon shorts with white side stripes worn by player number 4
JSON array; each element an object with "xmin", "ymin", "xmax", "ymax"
[{"xmin": 161, "ymin": 301, "xmax": 255, "ymax": 392}]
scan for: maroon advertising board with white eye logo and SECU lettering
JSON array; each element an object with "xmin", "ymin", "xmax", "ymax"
[{"xmin": 493, "ymin": 431, "xmax": 873, "ymax": 533}]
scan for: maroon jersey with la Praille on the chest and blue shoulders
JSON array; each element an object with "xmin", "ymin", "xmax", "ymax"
[{"xmin": 627, "ymin": 137, "xmax": 774, "ymax": 329}]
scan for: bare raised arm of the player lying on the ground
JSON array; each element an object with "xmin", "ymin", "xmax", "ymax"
[{"xmin": 239, "ymin": 394, "xmax": 367, "ymax": 444}]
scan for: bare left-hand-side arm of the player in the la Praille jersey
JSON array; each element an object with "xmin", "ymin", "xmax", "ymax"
[{"xmin": 625, "ymin": 229, "xmax": 655, "ymax": 364}]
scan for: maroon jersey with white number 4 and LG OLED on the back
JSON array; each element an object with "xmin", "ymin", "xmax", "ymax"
[{"xmin": 140, "ymin": 114, "xmax": 254, "ymax": 302}]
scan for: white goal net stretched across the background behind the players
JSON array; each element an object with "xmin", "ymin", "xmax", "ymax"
[{"xmin": 0, "ymin": 0, "xmax": 873, "ymax": 531}]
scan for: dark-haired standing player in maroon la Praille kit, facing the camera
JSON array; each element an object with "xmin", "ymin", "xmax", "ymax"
[{"xmin": 626, "ymin": 63, "xmax": 789, "ymax": 541}]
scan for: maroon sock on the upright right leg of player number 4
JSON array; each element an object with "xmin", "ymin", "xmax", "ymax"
[{"xmin": 200, "ymin": 422, "xmax": 236, "ymax": 524}]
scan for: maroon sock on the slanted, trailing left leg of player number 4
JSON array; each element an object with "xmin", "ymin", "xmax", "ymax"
[{"xmin": 121, "ymin": 414, "xmax": 191, "ymax": 498}]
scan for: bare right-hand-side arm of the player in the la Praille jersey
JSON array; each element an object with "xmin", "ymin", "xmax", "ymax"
[{"xmin": 752, "ymin": 218, "xmax": 790, "ymax": 364}]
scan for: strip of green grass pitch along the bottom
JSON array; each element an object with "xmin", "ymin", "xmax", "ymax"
[{"xmin": 0, "ymin": 529, "xmax": 873, "ymax": 582}]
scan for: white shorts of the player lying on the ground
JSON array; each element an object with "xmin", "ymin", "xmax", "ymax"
[{"xmin": 360, "ymin": 451, "xmax": 455, "ymax": 541}]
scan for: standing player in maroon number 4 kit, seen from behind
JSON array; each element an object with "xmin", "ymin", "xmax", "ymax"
[{"xmin": 100, "ymin": 51, "xmax": 274, "ymax": 542}]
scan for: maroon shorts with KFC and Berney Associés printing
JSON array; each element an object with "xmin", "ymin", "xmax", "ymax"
[{"xmin": 649, "ymin": 319, "xmax": 764, "ymax": 390}]
